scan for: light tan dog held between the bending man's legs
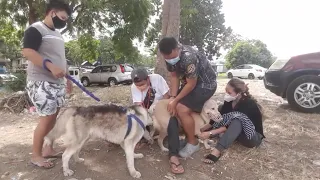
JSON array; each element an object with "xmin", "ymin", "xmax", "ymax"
[{"xmin": 149, "ymin": 97, "xmax": 220, "ymax": 151}]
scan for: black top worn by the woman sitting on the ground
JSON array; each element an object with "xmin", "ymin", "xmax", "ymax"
[{"xmin": 220, "ymin": 98, "xmax": 265, "ymax": 138}]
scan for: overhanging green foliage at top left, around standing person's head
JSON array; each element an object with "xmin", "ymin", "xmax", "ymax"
[{"xmin": 0, "ymin": 0, "xmax": 152, "ymax": 55}]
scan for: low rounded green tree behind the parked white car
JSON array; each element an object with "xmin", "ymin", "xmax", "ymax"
[{"xmin": 226, "ymin": 40, "xmax": 275, "ymax": 68}]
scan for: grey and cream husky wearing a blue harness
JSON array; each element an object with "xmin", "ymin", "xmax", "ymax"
[{"xmin": 45, "ymin": 104, "xmax": 153, "ymax": 178}]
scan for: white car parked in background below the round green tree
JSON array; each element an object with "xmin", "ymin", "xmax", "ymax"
[{"xmin": 227, "ymin": 64, "xmax": 267, "ymax": 79}]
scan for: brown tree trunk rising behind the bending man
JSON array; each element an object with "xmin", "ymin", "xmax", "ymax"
[{"xmin": 155, "ymin": 0, "xmax": 180, "ymax": 86}]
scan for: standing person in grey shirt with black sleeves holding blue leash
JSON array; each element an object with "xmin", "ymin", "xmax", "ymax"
[{"xmin": 22, "ymin": 0, "xmax": 72, "ymax": 168}]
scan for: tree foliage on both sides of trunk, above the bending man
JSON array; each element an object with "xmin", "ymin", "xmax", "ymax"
[{"xmin": 145, "ymin": 0, "xmax": 232, "ymax": 56}]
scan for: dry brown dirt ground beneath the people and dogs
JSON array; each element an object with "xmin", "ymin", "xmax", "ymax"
[{"xmin": 0, "ymin": 79, "xmax": 320, "ymax": 180}]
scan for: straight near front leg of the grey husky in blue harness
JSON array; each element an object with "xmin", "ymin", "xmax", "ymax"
[{"xmin": 123, "ymin": 140, "xmax": 141, "ymax": 178}]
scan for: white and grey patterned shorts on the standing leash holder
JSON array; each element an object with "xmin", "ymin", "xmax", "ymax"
[{"xmin": 26, "ymin": 81, "xmax": 66, "ymax": 116}]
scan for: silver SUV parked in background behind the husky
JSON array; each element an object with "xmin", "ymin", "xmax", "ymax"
[{"xmin": 81, "ymin": 64, "xmax": 133, "ymax": 86}]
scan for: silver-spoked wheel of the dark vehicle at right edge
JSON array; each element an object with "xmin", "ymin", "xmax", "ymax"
[{"xmin": 287, "ymin": 75, "xmax": 320, "ymax": 113}]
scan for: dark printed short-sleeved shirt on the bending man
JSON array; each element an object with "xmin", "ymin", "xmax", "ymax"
[{"xmin": 166, "ymin": 46, "xmax": 217, "ymax": 89}]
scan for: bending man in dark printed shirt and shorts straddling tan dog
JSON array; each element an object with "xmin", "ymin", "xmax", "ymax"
[{"xmin": 159, "ymin": 37, "xmax": 217, "ymax": 173}]
